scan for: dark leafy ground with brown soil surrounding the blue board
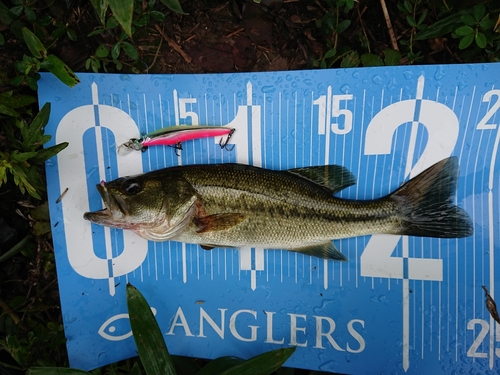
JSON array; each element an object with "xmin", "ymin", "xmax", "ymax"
[{"xmin": 0, "ymin": 0, "xmax": 500, "ymax": 374}]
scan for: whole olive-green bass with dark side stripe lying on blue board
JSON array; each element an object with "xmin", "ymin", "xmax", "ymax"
[{"xmin": 84, "ymin": 157, "xmax": 473, "ymax": 261}]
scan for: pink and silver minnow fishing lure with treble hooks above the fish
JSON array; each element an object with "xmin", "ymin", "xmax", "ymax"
[{"xmin": 119, "ymin": 125, "xmax": 236, "ymax": 156}]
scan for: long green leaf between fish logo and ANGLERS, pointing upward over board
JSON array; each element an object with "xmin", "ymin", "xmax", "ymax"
[{"xmin": 127, "ymin": 284, "xmax": 176, "ymax": 375}]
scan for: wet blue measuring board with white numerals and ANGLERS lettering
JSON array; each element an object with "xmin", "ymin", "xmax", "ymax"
[{"xmin": 39, "ymin": 64, "xmax": 500, "ymax": 374}]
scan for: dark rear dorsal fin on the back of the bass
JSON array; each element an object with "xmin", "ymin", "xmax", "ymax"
[{"xmin": 288, "ymin": 165, "xmax": 356, "ymax": 194}]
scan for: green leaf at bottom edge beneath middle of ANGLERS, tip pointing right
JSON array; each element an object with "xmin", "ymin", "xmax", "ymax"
[{"xmin": 214, "ymin": 347, "xmax": 296, "ymax": 375}]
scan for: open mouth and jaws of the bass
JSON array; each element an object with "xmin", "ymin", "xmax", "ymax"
[{"xmin": 83, "ymin": 181, "xmax": 128, "ymax": 228}]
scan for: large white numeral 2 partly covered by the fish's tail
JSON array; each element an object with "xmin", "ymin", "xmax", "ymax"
[{"xmin": 361, "ymin": 99, "xmax": 459, "ymax": 281}]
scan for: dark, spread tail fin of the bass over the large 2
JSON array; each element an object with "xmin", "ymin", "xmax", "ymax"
[{"xmin": 391, "ymin": 157, "xmax": 473, "ymax": 238}]
